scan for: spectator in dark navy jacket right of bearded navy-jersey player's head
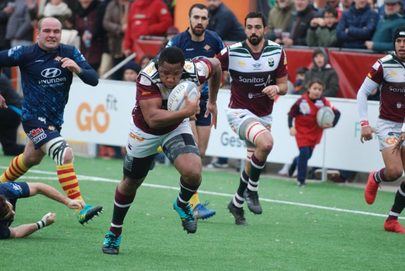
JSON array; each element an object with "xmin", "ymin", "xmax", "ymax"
[{"xmin": 206, "ymin": 0, "xmax": 246, "ymax": 41}]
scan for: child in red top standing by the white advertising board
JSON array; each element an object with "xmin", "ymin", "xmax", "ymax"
[{"xmin": 288, "ymin": 79, "xmax": 340, "ymax": 186}]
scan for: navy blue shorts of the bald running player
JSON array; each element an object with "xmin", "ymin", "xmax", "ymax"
[{"xmin": 22, "ymin": 120, "xmax": 61, "ymax": 149}]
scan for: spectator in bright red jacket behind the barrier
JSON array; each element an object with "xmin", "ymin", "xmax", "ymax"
[{"xmin": 123, "ymin": 0, "xmax": 173, "ymax": 56}]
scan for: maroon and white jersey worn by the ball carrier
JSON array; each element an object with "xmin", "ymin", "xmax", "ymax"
[{"xmin": 132, "ymin": 58, "xmax": 212, "ymax": 135}]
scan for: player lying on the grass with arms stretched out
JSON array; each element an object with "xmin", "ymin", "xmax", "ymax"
[{"xmin": 0, "ymin": 182, "xmax": 84, "ymax": 239}]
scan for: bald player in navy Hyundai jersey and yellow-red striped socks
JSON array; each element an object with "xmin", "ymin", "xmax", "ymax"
[{"xmin": 0, "ymin": 17, "xmax": 102, "ymax": 224}]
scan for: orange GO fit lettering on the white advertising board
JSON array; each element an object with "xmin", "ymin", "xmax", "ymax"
[{"xmin": 76, "ymin": 95, "xmax": 117, "ymax": 133}]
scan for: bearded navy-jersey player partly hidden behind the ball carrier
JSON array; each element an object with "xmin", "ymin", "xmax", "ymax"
[{"xmin": 167, "ymin": 4, "xmax": 224, "ymax": 219}]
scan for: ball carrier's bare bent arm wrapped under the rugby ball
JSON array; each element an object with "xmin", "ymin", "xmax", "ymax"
[{"xmin": 139, "ymin": 96, "xmax": 200, "ymax": 129}]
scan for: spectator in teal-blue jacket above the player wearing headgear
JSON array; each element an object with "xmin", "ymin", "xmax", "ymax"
[{"xmin": 365, "ymin": 0, "xmax": 405, "ymax": 52}]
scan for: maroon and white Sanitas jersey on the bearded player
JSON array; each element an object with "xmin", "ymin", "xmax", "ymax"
[{"xmin": 217, "ymin": 40, "xmax": 287, "ymax": 117}]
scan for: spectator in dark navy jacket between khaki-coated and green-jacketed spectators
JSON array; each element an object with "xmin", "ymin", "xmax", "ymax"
[{"xmin": 281, "ymin": 0, "xmax": 316, "ymax": 46}]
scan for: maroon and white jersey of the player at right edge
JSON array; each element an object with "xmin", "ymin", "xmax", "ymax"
[{"xmin": 367, "ymin": 55, "xmax": 405, "ymax": 123}]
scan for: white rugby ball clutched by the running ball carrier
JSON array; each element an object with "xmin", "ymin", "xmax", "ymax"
[{"xmin": 167, "ymin": 81, "xmax": 198, "ymax": 111}]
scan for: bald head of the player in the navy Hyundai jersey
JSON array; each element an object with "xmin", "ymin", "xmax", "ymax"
[{"xmin": 38, "ymin": 17, "xmax": 62, "ymax": 51}]
